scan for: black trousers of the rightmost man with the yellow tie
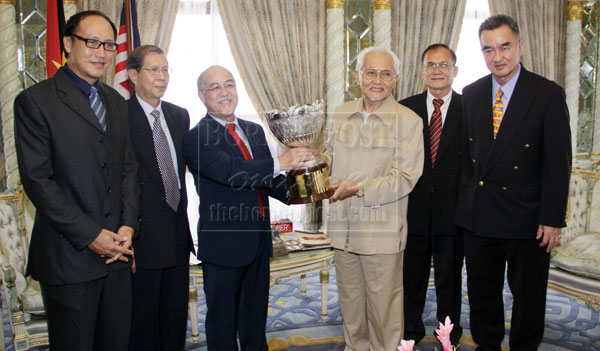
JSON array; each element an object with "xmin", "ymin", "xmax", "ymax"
[{"xmin": 464, "ymin": 232, "xmax": 550, "ymax": 351}]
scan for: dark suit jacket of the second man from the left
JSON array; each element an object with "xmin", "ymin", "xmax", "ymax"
[{"xmin": 127, "ymin": 96, "xmax": 194, "ymax": 269}]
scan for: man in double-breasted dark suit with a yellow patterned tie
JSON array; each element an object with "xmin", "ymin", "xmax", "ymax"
[{"xmin": 456, "ymin": 15, "xmax": 572, "ymax": 351}]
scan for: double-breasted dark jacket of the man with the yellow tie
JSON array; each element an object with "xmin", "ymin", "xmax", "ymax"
[{"xmin": 456, "ymin": 67, "xmax": 572, "ymax": 239}]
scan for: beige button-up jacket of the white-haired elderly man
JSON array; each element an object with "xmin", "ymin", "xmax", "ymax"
[{"xmin": 325, "ymin": 95, "xmax": 423, "ymax": 255}]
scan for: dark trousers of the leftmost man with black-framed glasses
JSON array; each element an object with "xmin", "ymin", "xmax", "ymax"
[{"xmin": 40, "ymin": 268, "xmax": 131, "ymax": 351}]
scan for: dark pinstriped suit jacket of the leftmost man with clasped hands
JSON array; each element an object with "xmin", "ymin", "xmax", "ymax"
[{"xmin": 14, "ymin": 68, "xmax": 139, "ymax": 285}]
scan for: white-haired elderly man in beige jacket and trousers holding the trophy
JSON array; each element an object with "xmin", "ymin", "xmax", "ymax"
[{"xmin": 326, "ymin": 47, "xmax": 423, "ymax": 351}]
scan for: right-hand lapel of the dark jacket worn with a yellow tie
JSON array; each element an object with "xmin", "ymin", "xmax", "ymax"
[{"xmin": 481, "ymin": 67, "xmax": 533, "ymax": 176}]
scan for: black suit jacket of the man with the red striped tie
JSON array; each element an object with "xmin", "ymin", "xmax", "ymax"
[{"xmin": 400, "ymin": 91, "xmax": 464, "ymax": 236}]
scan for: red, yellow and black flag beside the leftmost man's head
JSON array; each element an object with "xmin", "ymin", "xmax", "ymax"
[{"xmin": 46, "ymin": 0, "xmax": 65, "ymax": 78}]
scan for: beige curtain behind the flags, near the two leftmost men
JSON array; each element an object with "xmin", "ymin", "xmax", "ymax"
[{"xmin": 80, "ymin": 0, "xmax": 179, "ymax": 85}]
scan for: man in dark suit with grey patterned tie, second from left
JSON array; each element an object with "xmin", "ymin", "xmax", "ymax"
[{"xmin": 127, "ymin": 45, "xmax": 193, "ymax": 351}]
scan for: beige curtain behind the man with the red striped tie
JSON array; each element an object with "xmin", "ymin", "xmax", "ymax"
[{"xmin": 392, "ymin": 0, "xmax": 466, "ymax": 99}]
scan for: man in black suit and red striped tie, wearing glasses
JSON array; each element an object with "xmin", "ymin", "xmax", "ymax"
[{"xmin": 400, "ymin": 44, "xmax": 464, "ymax": 345}]
